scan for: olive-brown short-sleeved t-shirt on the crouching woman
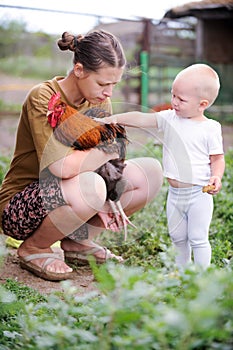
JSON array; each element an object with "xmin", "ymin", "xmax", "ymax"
[{"xmin": 0, "ymin": 77, "xmax": 112, "ymax": 226}]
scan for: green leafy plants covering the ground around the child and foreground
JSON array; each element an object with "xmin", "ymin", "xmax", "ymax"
[{"xmin": 0, "ymin": 143, "xmax": 233, "ymax": 350}]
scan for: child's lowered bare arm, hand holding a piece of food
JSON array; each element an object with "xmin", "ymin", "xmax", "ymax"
[{"xmin": 208, "ymin": 154, "xmax": 225, "ymax": 194}]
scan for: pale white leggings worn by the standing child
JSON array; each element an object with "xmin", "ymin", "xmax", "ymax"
[{"xmin": 167, "ymin": 186, "xmax": 213, "ymax": 268}]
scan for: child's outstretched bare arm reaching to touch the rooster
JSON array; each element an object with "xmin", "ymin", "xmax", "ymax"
[{"xmin": 98, "ymin": 111, "xmax": 157, "ymax": 128}]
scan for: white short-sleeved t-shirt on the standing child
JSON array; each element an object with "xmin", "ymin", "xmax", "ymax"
[{"xmin": 156, "ymin": 110, "xmax": 224, "ymax": 186}]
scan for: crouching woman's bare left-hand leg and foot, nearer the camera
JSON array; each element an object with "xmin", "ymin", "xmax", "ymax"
[{"xmin": 18, "ymin": 172, "xmax": 106, "ymax": 273}]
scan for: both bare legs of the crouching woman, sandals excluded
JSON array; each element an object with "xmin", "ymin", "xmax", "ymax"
[{"xmin": 18, "ymin": 158, "xmax": 163, "ymax": 273}]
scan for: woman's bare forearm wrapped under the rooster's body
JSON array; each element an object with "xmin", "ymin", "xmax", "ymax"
[{"xmin": 48, "ymin": 148, "xmax": 119, "ymax": 179}]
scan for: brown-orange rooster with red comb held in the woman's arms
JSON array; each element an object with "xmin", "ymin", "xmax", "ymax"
[{"xmin": 47, "ymin": 92, "xmax": 135, "ymax": 240}]
